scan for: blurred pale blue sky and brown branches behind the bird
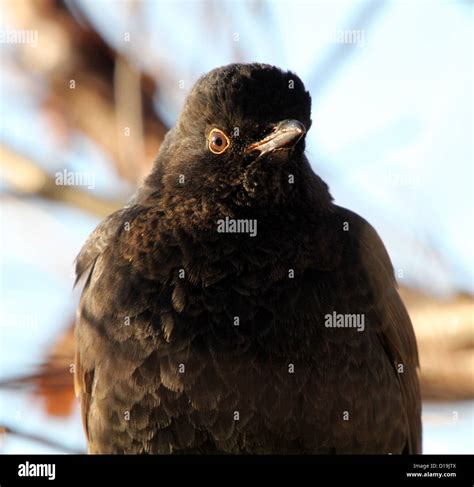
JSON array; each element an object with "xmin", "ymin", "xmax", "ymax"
[{"xmin": 0, "ymin": 0, "xmax": 474, "ymax": 453}]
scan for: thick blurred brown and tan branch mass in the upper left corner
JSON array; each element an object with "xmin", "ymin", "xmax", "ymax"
[{"xmin": 5, "ymin": 0, "xmax": 167, "ymax": 183}]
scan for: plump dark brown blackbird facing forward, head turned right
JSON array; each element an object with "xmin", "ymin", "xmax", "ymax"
[{"xmin": 74, "ymin": 63, "xmax": 422, "ymax": 454}]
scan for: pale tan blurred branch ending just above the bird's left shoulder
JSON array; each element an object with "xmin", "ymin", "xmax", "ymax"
[{"xmin": 0, "ymin": 146, "xmax": 122, "ymax": 216}]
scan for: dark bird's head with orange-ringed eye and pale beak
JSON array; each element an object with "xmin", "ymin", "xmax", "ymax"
[{"xmin": 145, "ymin": 64, "xmax": 322, "ymax": 215}]
